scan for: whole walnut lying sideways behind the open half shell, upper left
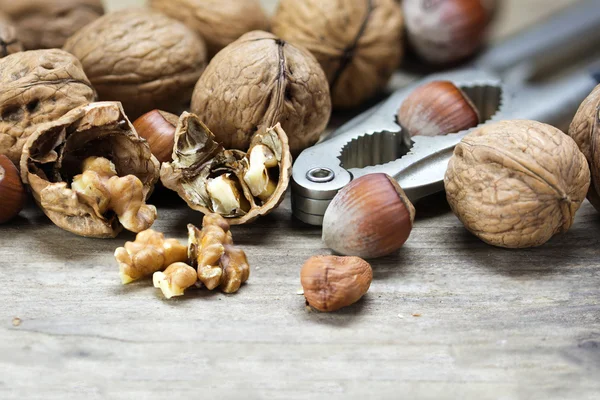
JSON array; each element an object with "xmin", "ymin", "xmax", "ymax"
[{"xmin": 64, "ymin": 9, "xmax": 206, "ymax": 119}]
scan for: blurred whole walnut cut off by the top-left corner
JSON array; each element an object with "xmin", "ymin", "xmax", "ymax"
[{"xmin": 0, "ymin": 0, "xmax": 104, "ymax": 50}]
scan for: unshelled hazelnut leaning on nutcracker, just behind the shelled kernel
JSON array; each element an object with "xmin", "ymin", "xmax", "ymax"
[{"xmin": 323, "ymin": 174, "xmax": 415, "ymax": 259}]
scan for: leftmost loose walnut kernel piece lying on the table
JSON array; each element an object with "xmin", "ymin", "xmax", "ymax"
[{"xmin": 115, "ymin": 229, "xmax": 186, "ymax": 285}]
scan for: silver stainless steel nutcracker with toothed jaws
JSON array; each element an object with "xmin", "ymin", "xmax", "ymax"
[{"xmin": 292, "ymin": 0, "xmax": 600, "ymax": 225}]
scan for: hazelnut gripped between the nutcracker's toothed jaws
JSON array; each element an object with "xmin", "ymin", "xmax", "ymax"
[{"xmin": 398, "ymin": 81, "xmax": 480, "ymax": 136}]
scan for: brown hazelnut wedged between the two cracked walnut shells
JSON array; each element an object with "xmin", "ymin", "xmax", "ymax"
[{"xmin": 133, "ymin": 110, "xmax": 179, "ymax": 163}]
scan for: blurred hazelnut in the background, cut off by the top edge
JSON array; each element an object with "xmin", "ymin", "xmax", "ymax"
[{"xmin": 402, "ymin": 0, "xmax": 490, "ymax": 64}]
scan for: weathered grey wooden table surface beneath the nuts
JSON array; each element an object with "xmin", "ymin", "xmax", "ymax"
[{"xmin": 0, "ymin": 0, "xmax": 600, "ymax": 400}]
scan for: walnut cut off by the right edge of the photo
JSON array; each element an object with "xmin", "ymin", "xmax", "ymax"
[{"xmin": 569, "ymin": 85, "xmax": 600, "ymax": 211}]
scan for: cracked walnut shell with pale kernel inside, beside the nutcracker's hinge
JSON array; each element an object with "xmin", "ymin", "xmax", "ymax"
[{"xmin": 160, "ymin": 112, "xmax": 292, "ymax": 225}]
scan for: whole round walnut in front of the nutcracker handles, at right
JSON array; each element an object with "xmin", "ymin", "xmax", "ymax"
[{"xmin": 445, "ymin": 121, "xmax": 590, "ymax": 248}]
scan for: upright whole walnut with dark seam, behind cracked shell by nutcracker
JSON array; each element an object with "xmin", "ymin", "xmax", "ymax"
[{"xmin": 192, "ymin": 31, "xmax": 331, "ymax": 154}]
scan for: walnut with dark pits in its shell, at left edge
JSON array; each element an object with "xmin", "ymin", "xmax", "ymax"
[{"xmin": 0, "ymin": 50, "xmax": 96, "ymax": 165}]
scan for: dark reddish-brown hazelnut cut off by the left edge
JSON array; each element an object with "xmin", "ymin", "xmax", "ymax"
[{"xmin": 0, "ymin": 155, "xmax": 27, "ymax": 224}]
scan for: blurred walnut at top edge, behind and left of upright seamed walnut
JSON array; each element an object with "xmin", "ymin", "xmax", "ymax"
[{"xmin": 149, "ymin": 0, "xmax": 269, "ymax": 58}]
